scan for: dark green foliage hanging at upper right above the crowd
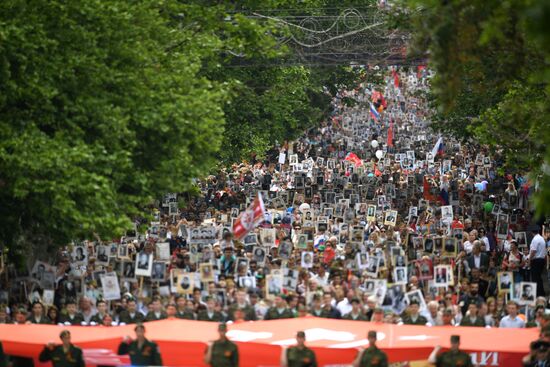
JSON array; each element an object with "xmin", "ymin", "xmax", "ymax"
[{"xmin": 406, "ymin": 0, "xmax": 550, "ymax": 214}]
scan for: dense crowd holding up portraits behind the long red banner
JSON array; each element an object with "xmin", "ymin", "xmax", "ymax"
[{"xmin": 0, "ymin": 68, "xmax": 550, "ymax": 366}]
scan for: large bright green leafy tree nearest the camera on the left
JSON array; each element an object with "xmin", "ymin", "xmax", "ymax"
[{"xmin": 0, "ymin": 0, "xmax": 228, "ymax": 255}]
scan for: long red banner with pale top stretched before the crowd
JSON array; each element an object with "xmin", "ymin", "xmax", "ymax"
[{"xmin": 0, "ymin": 317, "xmax": 538, "ymax": 367}]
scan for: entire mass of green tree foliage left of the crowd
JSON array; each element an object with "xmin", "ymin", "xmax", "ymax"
[{"xmin": 0, "ymin": 0, "xmax": 376, "ymax": 256}]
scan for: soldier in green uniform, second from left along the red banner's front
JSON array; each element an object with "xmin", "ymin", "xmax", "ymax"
[{"xmin": 118, "ymin": 324, "xmax": 162, "ymax": 366}]
